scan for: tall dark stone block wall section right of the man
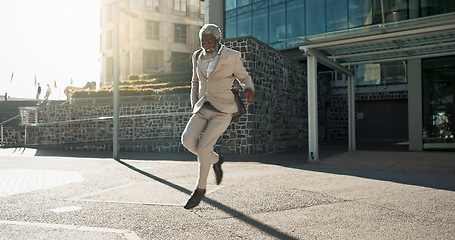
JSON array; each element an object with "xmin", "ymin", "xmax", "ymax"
[{"xmin": 222, "ymin": 37, "xmax": 308, "ymax": 154}]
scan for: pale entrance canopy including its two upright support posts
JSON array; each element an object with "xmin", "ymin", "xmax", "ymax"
[{"xmin": 283, "ymin": 13, "xmax": 455, "ymax": 162}]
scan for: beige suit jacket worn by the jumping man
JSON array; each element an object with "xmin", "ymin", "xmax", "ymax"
[{"xmin": 191, "ymin": 46, "xmax": 254, "ymax": 113}]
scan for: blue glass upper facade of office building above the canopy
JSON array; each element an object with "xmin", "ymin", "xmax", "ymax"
[{"xmin": 224, "ymin": 0, "xmax": 455, "ymax": 50}]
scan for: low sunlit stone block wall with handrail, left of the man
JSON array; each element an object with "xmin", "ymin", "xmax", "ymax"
[{"xmin": 27, "ymin": 99, "xmax": 191, "ymax": 151}]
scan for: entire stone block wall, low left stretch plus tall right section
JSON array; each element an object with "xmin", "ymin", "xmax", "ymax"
[{"xmin": 20, "ymin": 37, "xmax": 308, "ymax": 154}]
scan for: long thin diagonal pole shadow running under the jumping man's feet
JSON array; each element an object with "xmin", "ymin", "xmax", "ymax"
[{"xmin": 116, "ymin": 160, "xmax": 296, "ymax": 239}]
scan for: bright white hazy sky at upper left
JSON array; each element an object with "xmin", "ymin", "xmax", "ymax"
[{"xmin": 0, "ymin": 0, "xmax": 100, "ymax": 100}]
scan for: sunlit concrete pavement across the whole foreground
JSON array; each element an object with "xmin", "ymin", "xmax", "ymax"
[{"xmin": 0, "ymin": 148, "xmax": 455, "ymax": 239}]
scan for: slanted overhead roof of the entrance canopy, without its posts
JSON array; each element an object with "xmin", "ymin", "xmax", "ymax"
[{"xmin": 296, "ymin": 13, "xmax": 455, "ymax": 66}]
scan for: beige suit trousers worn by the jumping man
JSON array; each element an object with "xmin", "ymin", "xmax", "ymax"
[{"xmin": 182, "ymin": 106, "xmax": 232, "ymax": 189}]
